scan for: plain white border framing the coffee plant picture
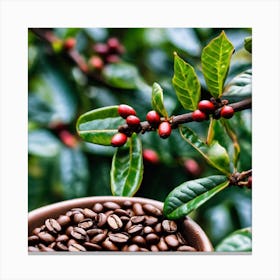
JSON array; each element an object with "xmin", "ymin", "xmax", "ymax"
[{"xmin": 0, "ymin": 0, "xmax": 280, "ymax": 280}]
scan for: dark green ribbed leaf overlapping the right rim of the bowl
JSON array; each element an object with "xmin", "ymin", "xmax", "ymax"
[{"xmin": 163, "ymin": 175, "xmax": 229, "ymax": 219}]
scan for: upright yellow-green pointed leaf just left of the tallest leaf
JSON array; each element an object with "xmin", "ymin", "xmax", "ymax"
[{"xmin": 172, "ymin": 53, "xmax": 201, "ymax": 111}]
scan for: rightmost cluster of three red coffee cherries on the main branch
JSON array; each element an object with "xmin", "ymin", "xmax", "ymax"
[{"xmin": 192, "ymin": 100, "xmax": 234, "ymax": 122}]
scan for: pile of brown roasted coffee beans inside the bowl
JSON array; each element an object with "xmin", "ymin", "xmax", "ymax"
[{"xmin": 28, "ymin": 201, "xmax": 196, "ymax": 252}]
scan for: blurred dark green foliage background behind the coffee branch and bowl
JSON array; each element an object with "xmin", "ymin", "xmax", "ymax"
[{"xmin": 28, "ymin": 28, "xmax": 251, "ymax": 245}]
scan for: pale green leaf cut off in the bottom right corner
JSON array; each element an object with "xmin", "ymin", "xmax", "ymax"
[{"xmin": 215, "ymin": 228, "xmax": 252, "ymax": 252}]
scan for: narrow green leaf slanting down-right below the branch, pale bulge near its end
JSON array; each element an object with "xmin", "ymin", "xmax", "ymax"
[{"xmin": 179, "ymin": 126, "xmax": 230, "ymax": 175}]
